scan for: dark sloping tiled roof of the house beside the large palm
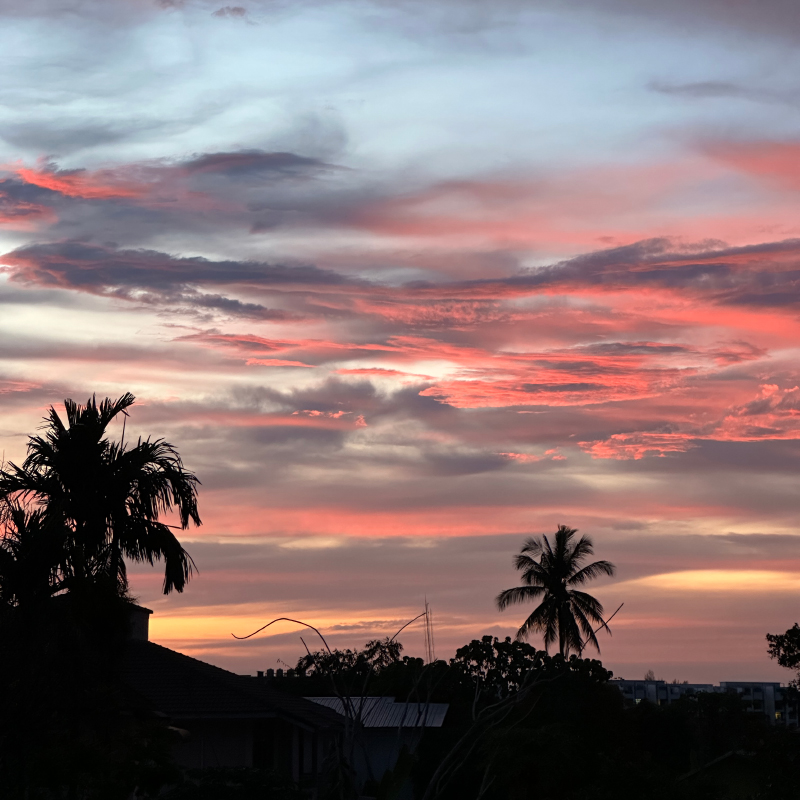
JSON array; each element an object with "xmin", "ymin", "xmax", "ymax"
[{"xmin": 122, "ymin": 640, "xmax": 343, "ymax": 729}]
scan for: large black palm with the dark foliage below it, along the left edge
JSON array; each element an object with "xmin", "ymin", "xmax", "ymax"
[{"xmin": 0, "ymin": 394, "xmax": 200, "ymax": 800}]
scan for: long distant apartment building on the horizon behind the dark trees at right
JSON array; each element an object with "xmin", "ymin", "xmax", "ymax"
[{"xmin": 611, "ymin": 678, "xmax": 798, "ymax": 727}]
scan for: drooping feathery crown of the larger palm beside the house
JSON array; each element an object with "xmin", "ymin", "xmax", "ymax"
[{"xmin": 0, "ymin": 393, "xmax": 201, "ymax": 594}]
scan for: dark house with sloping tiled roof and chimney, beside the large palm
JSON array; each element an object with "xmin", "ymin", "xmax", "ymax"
[{"xmin": 122, "ymin": 606, "xmax": 343, "ymax": 786}]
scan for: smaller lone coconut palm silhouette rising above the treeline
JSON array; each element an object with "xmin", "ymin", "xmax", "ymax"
[{"xmin": 497, "ymin": 525, "xmax": 615, "ymax": 658}]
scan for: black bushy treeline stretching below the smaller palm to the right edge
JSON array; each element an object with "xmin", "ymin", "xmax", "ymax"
[{"xmin": 272, "ymin": 636, "xmax": 800, "ymax": 800}]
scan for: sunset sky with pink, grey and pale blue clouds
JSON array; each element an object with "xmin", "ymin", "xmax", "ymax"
[{"xmin": 0, "ymin": 0, "xmax": 800, "ymax": 682}]
